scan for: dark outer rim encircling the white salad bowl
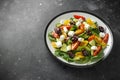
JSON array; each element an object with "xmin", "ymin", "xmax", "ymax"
[{"xmin": 44, "ymin": 10, "xmax": 114, "ymax": 68}]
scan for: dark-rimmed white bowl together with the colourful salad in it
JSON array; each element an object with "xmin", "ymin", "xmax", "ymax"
[{"xmin": 45, "ymin": 11, "xmax": 113, "ymax": 67}]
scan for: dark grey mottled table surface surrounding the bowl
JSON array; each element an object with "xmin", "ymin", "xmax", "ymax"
[{"xmin": 0, "ymin": 0, "xmax": 120, "ymax": 80}]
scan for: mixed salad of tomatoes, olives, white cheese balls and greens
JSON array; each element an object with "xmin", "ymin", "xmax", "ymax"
[{"xmin": 48, "ymin": 14, "xmax": 109, "ymax": 64}]
